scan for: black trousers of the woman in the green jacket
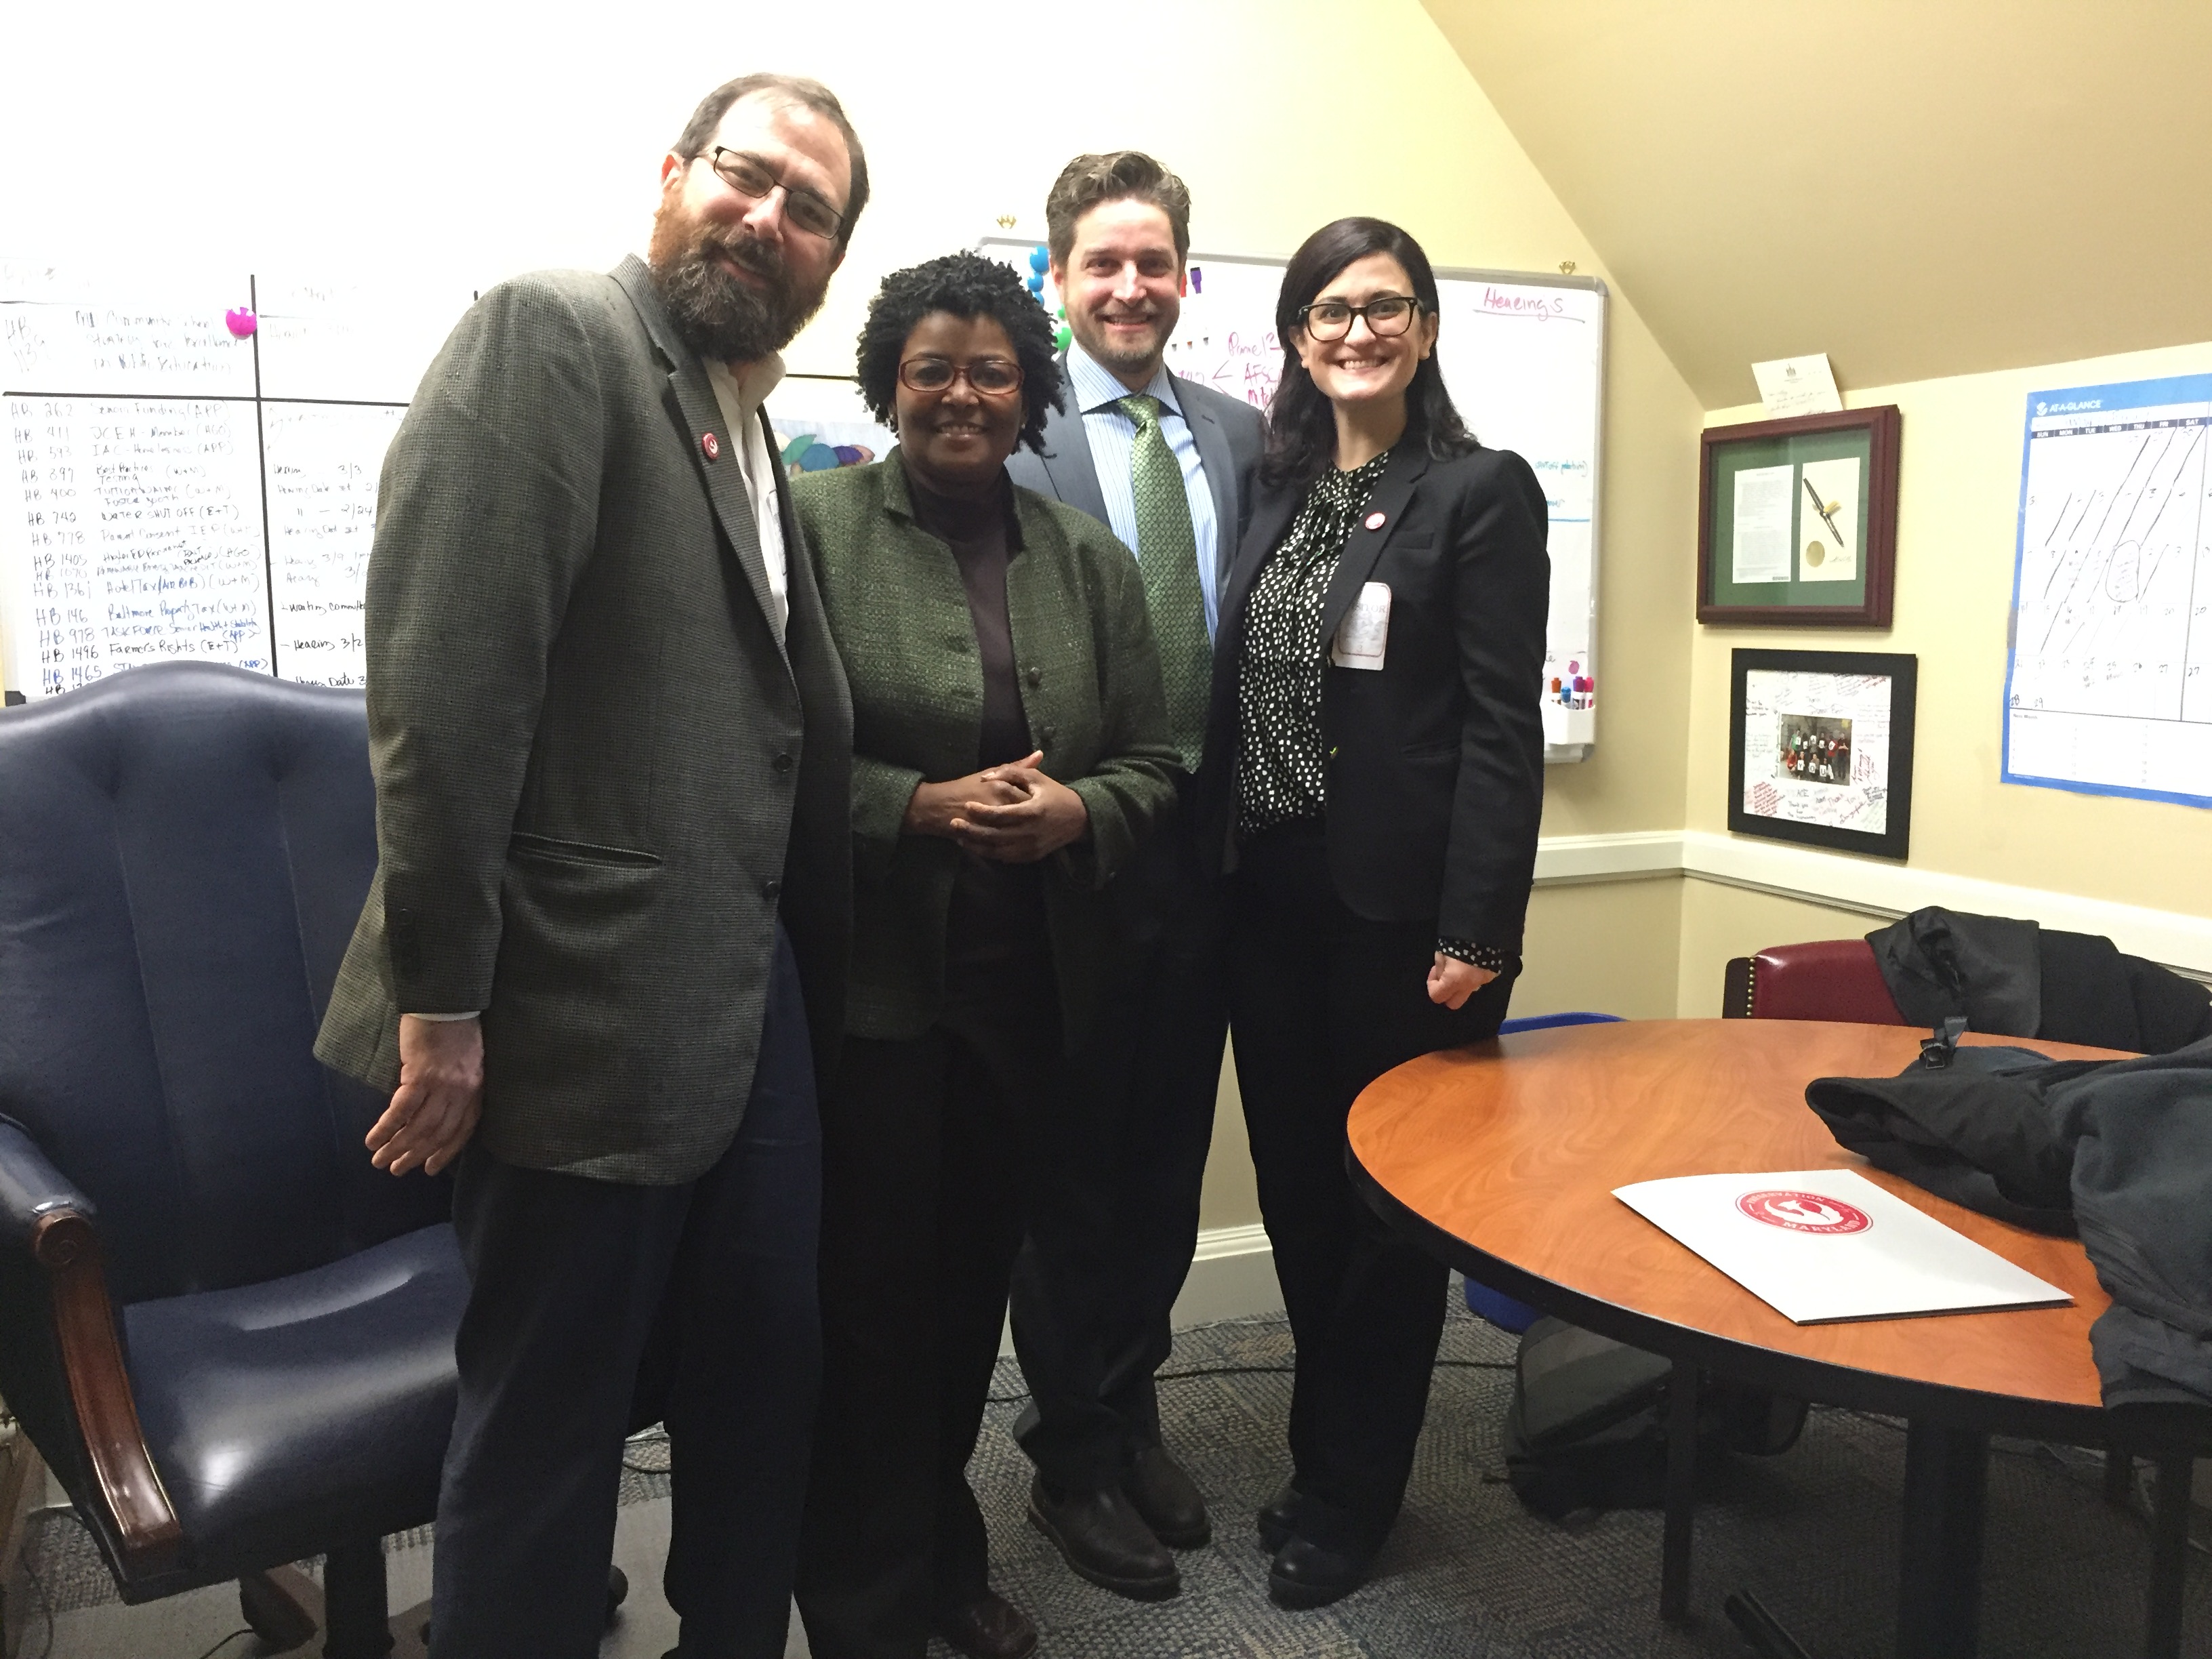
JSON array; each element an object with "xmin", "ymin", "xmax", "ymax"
[{"xmin": 798, "ymin": 938, "xmax": 1113, "ymax": 1659}]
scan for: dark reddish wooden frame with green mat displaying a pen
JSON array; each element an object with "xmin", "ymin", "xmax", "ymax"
[{"xmin": 1696, "ymin": 403, "xmax": 1900, "ymax": 628}]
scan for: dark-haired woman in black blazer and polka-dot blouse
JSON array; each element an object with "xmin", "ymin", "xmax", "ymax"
[{"xmin": 1201, "ymin": 219, "xmax": 1551, "ymax": 1606}]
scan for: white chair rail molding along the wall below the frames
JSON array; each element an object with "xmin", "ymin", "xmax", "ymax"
[{"xmin": 1535, "ymin": 830, "xmax": 2212, "ymax": 978}]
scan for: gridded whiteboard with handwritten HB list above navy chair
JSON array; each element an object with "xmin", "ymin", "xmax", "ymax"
[{"xmin": 0, "ymin": 259, "xmax": 473, "ymax": 699}]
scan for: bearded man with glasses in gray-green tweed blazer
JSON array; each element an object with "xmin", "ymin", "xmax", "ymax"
[{"xmin": 316, "ymin": 75, "xmax": 867, "ymax": 1659}]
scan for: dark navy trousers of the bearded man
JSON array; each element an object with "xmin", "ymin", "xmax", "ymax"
[{"xmin": 431, "ymin": 929, "xmax": 821, "ymax": 1659}]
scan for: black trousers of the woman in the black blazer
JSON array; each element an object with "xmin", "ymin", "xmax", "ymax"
[{"xmin": 1230, "ymin": 827, "xmax": 1511, "ymax": 1551}]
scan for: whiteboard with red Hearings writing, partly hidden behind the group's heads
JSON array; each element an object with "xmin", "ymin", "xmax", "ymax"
[{"xmin": 978, "ymin": 237, "xmax": 1608, "ymax": 761}]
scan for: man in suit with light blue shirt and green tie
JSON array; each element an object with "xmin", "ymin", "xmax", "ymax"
[{"xmin": 1006, "ymin": 150, "xmax": 1261, "ymax": 1595}]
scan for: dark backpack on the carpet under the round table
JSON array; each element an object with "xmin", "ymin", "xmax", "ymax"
[{"xmin": 1504, "ymin": 1318, "xmax": 1805, "ymax": 1519}]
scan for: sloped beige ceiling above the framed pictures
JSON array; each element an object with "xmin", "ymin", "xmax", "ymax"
[{"xmin": 1422, "ymin": 0, "xmax": 2212, "ymax": 407}]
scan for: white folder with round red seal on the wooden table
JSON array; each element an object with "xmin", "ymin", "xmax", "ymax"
[{"xmin": 1612, "ymin": 1170, "xmax": 2072, "ymax": 1325}]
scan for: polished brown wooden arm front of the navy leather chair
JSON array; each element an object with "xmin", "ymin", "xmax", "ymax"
[{"xmin": 31, "ymin": 1210, "xmax": 184, "ymax": 1577}]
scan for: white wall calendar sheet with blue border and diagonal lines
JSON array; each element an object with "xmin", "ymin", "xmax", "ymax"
[{"xmin": 2002, "ymin": 374, "xmax": 2212, "ymax": 807}]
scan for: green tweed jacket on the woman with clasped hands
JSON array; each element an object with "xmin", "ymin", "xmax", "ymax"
[{"xmin": 792, "ymin": 449, "xmax": 1179, "ymax": 1046}]
